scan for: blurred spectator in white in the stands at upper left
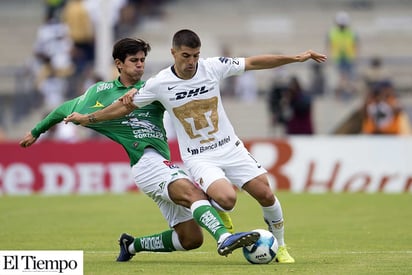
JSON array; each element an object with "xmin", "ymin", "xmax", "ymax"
[{"xmin": 23, "ymin": 14, "xmax": 74, "ymax": 114}]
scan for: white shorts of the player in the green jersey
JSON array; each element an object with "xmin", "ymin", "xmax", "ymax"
[{"xmin": 132, "ymin": 148, "xmax": 193, "ymax": 227}]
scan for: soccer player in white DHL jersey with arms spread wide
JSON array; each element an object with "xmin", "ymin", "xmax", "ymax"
[{"xmin": 66, "ymin": 29, "xmax": 326, "ymax": 263}]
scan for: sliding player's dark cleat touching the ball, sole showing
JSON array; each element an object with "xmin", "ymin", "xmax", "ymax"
[{"xmin": 217, "ymin": 231, "xmax": 260, "ymax": 256}]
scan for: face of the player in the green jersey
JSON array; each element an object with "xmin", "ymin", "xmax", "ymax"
[{"xmin": 116, "ymin": 51, "xmax": 146, "ymax": 86}]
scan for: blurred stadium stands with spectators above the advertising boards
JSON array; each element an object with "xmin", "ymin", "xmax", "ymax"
[{"xmin": 0, "ymin": 0, "xmax": 412, "ymax": 141}]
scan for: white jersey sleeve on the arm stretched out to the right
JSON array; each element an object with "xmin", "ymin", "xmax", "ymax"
[{"xmin": 206, "ymin": 57, "xmax": 245, "ymax": 79}]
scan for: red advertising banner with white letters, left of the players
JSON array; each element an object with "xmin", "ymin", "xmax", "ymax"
[{"xmin": 0, "ymin": 141, "xmax": 136, "ymax": 195}]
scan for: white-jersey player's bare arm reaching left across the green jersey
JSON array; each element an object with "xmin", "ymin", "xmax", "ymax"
[{"xmin": 64, "ymin": 100, "xmax": 136, "ymax": 126}]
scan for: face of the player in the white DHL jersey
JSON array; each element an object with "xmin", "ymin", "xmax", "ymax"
[{"xmin": 172, "ymin": 46, "xmax": 200, "ymax": 79}]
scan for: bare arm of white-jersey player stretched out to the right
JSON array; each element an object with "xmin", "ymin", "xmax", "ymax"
[{"xmin": 245, "ymin": 50, "xmax": 327, "ymax": 71}]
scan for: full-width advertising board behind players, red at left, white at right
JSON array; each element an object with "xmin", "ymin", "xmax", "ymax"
[{"xmin": 0, "ymin": 137, "xmax": 412, "ymax": 196}]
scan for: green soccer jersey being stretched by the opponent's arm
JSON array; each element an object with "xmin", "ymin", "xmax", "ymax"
[{"xmin": 31, "ymin": 79, "xmax": 170, "ymax": 166}]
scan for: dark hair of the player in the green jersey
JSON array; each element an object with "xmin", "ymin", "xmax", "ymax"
[{"xmin": 112, "ymin": 38, "xmax": 151, "ymax": 62}]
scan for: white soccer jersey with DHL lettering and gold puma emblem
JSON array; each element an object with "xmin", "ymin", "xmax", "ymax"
[{"xmin": 133, "ymin": 57, "xmax": 245, "ymax": 160}]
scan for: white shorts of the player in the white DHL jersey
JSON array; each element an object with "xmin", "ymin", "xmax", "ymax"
[{"xmin": 185, "ymin": 142, "xmax": 267, "ymax": 192}]
